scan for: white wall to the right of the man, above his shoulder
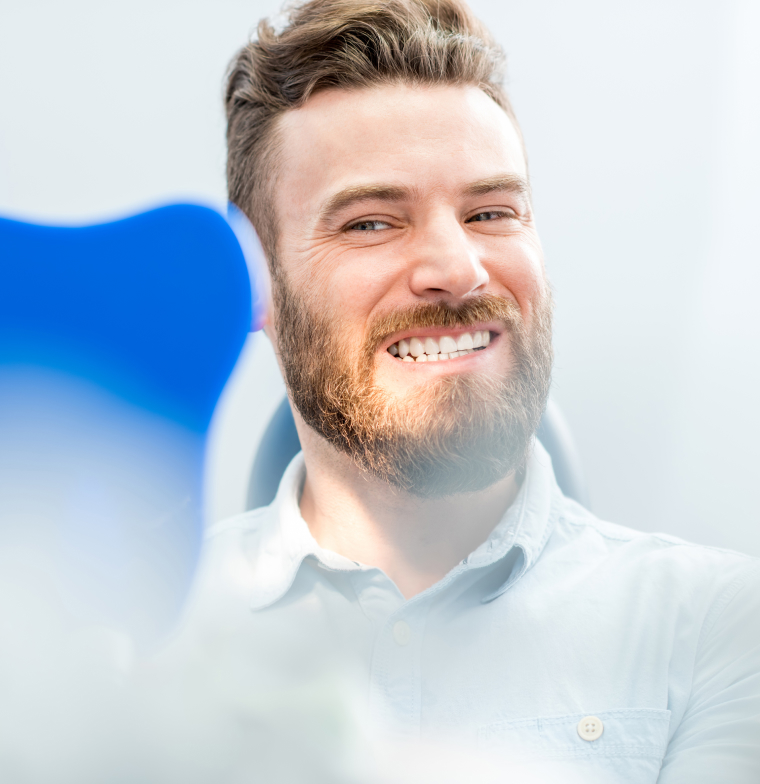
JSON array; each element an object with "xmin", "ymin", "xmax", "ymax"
[{"xmin": 477, "ymin": 0, "xmax": 760, "ymax": 554}]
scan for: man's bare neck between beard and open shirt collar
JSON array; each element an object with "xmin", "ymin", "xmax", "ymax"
[{"xmin": 298, "ymin": 422, "xmax": 519, "ymax": 599}]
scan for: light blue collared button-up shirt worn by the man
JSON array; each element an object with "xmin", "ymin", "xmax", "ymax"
[{"xmin": 180, "ymin": 443, "xmax": 760, "ymax": 784}]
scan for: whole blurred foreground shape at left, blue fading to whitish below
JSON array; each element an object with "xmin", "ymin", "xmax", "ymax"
[{"xmin": 0, "ymin": 205, "xmax": 256, "ymax": 645}]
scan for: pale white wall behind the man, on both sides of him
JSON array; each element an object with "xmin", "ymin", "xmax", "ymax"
[{"xmin": 0, "ymin": 0, "xmax": 760, "ymax": 554}]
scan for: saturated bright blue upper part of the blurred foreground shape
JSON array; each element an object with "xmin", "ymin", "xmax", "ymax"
[{"xmin": 0, "ymin": 205, "xmax": 252, "ymax": 432}]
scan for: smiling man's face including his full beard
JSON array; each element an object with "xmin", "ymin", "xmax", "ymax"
[{"xmin": 270, "ymin": 84, "xmax": 551, "ymax": 496}]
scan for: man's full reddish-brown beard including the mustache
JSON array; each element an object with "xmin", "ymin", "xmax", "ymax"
[{"xmin": 273, "ymin": 272, "xmax": 553, "ymax": 499}]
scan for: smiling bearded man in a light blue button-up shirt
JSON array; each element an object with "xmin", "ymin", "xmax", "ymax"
[{"xmin": 175, "ymin": 0, "xmax": 760, "ymax": 784}]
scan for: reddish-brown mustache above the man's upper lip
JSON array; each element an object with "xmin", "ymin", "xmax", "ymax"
[{"xmin": 366, "ymin": 294, "xmax": 523, "ymax": 352}]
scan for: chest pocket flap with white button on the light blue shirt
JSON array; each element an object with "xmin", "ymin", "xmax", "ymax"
[{"xmin": 478, "ymin": 708, "xmax": 670, "ymax": 764}]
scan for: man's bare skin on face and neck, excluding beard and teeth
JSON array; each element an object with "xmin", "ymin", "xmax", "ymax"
[{"xmin": 266, "ymin": 84, "xmax": 547, "ymax": 598}]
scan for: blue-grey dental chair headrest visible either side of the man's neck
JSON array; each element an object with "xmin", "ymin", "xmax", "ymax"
[{"xmin": 246, "ymin": 398, "xmax": 589, "ymax": 509}]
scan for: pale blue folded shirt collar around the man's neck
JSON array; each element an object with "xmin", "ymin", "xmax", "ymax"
[{"xmin": 247, "ymin": 441, "xmax": 561, "ymax": 610}]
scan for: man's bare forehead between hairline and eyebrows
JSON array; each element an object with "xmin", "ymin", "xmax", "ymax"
[{"xmin": 276, "ymin": 84, "xmax": 527, "ymax": 217}]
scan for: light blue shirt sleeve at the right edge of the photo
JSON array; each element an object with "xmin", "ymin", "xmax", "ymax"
[{"xmin": 658, "ymin": 562, "xmax": 760, "ymax": 784}]
